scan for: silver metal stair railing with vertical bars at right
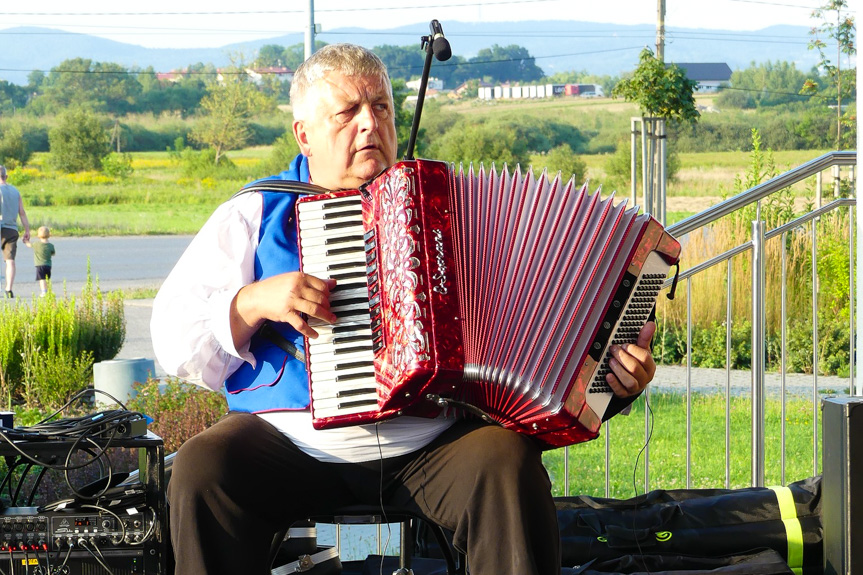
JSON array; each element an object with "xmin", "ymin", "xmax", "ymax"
[{"xmin": 563, "ymin": 151, "xmax": 857, "ymax": 497}]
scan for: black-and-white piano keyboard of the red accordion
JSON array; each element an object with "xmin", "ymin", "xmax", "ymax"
[{"xmin": 298, "ymin": 194, "xmax": 378, "ymax": 417}]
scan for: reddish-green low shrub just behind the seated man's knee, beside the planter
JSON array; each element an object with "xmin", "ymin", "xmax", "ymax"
[{"xmin": 126, "ymin": 378, "xmax": 228, "ymax": 453}]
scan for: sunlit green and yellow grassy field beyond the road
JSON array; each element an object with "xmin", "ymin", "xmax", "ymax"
[{"xmin": 18, "ymin": 147, "xmax": 830, "ymax": 236}]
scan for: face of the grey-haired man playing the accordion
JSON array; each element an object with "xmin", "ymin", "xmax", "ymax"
[{"xmin": 294, "ymin": 72, "xmax": 398, "ymax": 190}]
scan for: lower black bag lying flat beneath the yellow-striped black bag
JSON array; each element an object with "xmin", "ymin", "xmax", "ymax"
[{"xmin": 562, "ymin": 549, "xmax": 794, "ymax": 575}]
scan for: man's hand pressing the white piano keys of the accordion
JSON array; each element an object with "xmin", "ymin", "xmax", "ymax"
[{"xmin": 231, "ymin": 272, "xmax": 336, "ymax": 349}]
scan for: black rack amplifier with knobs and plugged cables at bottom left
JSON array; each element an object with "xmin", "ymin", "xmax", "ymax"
[{"xmin": 0, "ymin": 506, "xmax": 160, "ymax": 575}]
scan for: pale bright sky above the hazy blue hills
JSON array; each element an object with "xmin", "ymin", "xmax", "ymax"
[{"xmin": 0, "ymin": 0, "xmax": 852, "ymax": 48}]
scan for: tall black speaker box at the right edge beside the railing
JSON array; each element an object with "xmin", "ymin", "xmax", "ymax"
[{"xmin": 821, "ymin": 397, "xmax": 863, "ymax": 575}]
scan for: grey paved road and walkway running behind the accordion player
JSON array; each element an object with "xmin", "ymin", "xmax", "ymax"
[{"xmin": 1, "ymin": 236, "xmax": 849, "ymax": 396}]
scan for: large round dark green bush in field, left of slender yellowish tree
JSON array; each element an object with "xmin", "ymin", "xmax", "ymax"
[{"xmin": 48, "ymin": 108, "xmax": 110, "ymax": 172}]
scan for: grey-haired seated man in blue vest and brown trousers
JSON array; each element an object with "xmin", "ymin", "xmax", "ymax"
[{"xmin": 151, "ymin": 44, "xmax": 654, "ymax": 575}]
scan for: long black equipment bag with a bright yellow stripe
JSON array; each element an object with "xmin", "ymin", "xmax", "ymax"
[{"xmin": 555, "ymin": 476, "xmax": 823, "ymax": 575}]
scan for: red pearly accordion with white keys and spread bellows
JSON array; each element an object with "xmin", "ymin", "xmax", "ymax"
[{"xmin": 297, "ymin": 160, "xmax": 680, "ymax": 448}]
